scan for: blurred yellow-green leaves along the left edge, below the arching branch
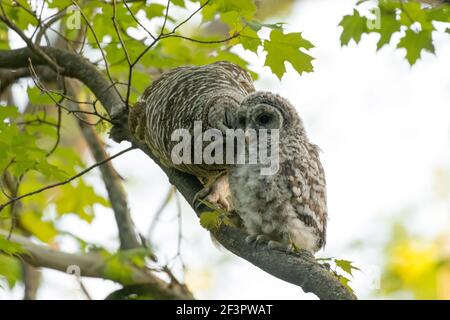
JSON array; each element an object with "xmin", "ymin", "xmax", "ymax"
[{"xmin": 0, "ymin": 106, "xmax": 110, "ymax": 287}]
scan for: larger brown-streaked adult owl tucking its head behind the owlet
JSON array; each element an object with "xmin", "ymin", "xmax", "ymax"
[{"xmin": 128, "ymin": 61, "xmax": 255, "ymax": 184}]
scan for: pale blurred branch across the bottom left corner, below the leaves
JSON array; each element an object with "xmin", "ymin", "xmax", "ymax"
[{"xmin": 0, "ymin": 230, "xmax": 193, "ymax": 299}]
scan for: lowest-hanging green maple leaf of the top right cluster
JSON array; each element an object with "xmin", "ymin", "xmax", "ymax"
[{"xmin": 397, "ymin": 29, "xmax": 435, "ymax": 65}]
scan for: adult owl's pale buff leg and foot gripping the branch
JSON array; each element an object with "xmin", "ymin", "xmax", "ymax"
[{"xmin": 194, "ymin": 175, "xmax": 233, "ymax": 212}]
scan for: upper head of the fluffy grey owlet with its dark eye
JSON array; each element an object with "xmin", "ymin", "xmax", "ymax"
[{"xmin": 235, "ymin": 91, "xmax": 304, "ymax": 134}]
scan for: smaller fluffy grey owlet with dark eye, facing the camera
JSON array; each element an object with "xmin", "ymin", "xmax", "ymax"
[{"xmin": 228, "ymin": 91, "xmax": 327, "ymax": 253}]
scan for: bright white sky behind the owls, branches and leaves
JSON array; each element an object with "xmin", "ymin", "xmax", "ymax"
[{"xmin": 0, "ymin": 0, "xmax": 450, "ymax": 299}]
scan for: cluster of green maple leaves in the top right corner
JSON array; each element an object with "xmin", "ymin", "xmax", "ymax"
[{"xmin": 339, "ymin": 0, "xmax": 450, "ymax": 65}]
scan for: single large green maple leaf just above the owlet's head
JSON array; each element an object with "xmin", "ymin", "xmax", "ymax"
[{"xmin": 264, "ymin": 30, "xmax": 314, "ymax": 79}]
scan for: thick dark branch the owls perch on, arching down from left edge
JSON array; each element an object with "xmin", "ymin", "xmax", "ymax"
[{"xmin": 0, "ymin": 47, "xmax": 356, "ymax": 299}]
